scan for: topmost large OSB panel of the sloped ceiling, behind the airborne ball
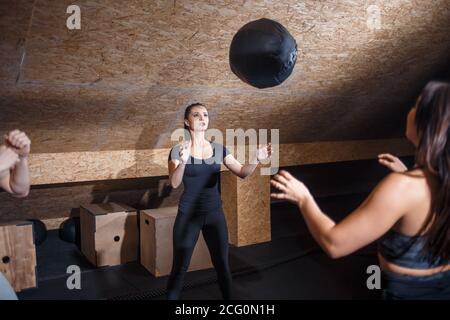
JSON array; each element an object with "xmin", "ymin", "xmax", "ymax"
[{"xmin": 17, "ymin": 0, "xmax": 450, "ymax": 89}]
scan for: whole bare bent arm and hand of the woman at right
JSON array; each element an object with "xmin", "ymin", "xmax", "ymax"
[{"xmin": 271, "ymin": 171, "xmax": 414, "ymax": 258}]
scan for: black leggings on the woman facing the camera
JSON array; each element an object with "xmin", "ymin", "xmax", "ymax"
[{"xmin": 167, "ymin": 209, "xmax": 231, "ymax": 300}]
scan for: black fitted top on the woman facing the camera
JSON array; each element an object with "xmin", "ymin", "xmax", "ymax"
[{"xmin": 169, "ymin": 142, "xmax": 230, "ymax": 214}]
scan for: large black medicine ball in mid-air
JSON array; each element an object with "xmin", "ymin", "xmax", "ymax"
[{"xmin": 230, "ymin": 18, "xmax": 297, "ymax": 89}]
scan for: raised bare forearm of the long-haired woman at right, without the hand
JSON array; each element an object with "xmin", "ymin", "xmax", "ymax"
[{"xmin": 299, "ymin": 195, "xmax": 336, "ymax": 258}]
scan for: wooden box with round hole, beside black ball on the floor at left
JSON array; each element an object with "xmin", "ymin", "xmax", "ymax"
[{"xmin": 80, "ymin": 202, "xmax": 139, "ymax": 267}]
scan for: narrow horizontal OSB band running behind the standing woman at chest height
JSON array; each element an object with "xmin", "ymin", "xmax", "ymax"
[{"xmin": 30, "ymin": 139, "xmax": 414, "ymax": 185}]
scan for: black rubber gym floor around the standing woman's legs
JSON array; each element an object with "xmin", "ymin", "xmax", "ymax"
[{"xmin": 18, "ymin": 194, "xmax": 380, "ymax": 300}]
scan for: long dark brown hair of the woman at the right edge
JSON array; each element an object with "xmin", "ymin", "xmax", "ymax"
[{"xmin": 415, "ymin": 81, "xmax": 450, "ymax": 263}]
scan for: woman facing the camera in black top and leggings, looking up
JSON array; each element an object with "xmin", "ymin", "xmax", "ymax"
[{"xmin": 167, "ymin": 103, "xmax": 272, "ymax": 300}]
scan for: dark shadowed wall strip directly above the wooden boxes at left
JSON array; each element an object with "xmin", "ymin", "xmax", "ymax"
[{"xmin": 0, "ymin": 177, "xmax": 183, "ymax": 229}]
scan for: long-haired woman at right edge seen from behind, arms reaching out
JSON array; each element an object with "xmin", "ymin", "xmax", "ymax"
[{"xmin": 271, "ymin": 82, "xmax": 450, "ymax": 299}]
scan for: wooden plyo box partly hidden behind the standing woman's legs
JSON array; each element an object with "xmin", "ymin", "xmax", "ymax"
[{"xmin": 140, "ymin": 207, "xmax": 213, "ymax": 277}]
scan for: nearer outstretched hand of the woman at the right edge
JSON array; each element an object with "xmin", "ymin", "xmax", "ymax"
[{"xmin": 270, "ymin": 170, "xmax": 311, "ymax": 206}]
